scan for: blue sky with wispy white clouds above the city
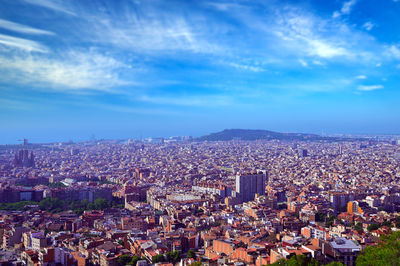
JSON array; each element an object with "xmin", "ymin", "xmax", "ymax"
[{"xmin": 0, "ymin": 0, "xmax": 400, "ymax": 143}]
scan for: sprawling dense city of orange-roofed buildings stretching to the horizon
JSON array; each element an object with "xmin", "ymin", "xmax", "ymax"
[{"xmin": 0, "ymin": 134, "xmax": 400, "ymax": 266}]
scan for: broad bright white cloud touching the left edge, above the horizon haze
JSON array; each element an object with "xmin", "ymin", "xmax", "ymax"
[{"xmin": 0, "ymin": 51, "xmax": 127, "ymax": 92}]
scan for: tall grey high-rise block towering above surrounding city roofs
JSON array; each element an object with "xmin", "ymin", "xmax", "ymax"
[{"xmin": 236, "ymin": 171, "xmax": 267, "ymax": 202}]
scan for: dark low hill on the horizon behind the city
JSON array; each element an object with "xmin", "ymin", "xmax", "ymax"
[{"xmin": 195, "ymin": 129, "xmax": 345, "ymax": 141}]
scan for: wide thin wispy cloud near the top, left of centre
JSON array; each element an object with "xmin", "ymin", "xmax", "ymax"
[{"xmin": 89, "ymin": 14, "xmax": 224, "ymax": 54}]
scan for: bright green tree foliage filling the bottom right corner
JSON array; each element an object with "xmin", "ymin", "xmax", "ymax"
[{"xmin": 356, "ymin": 232, "xmax": 400, "ymax": 266}]
